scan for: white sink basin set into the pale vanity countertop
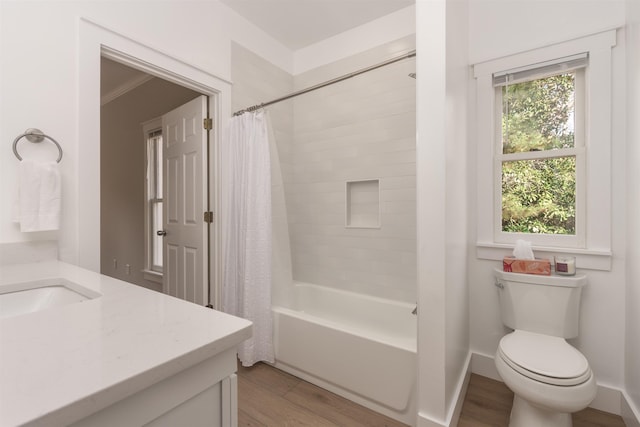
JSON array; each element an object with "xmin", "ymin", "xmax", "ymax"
[{"xmin": 0, "ymin": 279, "xmax": 101, "ymax": 319}]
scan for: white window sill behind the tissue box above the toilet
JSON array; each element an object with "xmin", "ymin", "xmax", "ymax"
[{"xmin": 476, "ymin": 242, "xmax": 612, "ymax": 271}]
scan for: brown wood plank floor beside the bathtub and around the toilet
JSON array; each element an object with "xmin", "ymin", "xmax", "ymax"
[{"xmin": 238, "ymin": 363, "xmax": 624, "ymax": 427}]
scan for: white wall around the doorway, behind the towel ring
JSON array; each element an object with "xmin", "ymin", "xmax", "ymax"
[{"xmin": 0, "ymin": 1, "xmax": 293, "ymax": 267}]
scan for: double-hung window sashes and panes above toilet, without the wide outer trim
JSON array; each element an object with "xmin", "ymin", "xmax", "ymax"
[{"xmin": 493, "ymin": 55, "xmax": 588, "ymax": 241}]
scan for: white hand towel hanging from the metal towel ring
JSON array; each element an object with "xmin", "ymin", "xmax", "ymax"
[{"xmin": 14, "ymin": 159, "xmax": 61, "ymax": 232}]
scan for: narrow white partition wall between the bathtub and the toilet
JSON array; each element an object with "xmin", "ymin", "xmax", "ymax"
[{"xmin": 417, "ymin": 0, "xmax": 469, "ymax": 427}]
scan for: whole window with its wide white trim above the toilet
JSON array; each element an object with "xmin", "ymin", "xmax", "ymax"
[{"xmin": 474, "ymin": 30, "xmax": 616, "ymax": 270}]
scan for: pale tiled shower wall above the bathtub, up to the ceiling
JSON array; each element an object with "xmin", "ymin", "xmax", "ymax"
[{"xmin": 232, "ymin": 38, "xmax": 416, "ymax": 302}]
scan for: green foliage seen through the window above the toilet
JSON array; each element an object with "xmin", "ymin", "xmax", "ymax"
[{"xmin": 502, "ymin": 73, "xmax": 576, "ymax": 234}]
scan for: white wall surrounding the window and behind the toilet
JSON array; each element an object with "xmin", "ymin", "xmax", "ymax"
[{"xmin": 468, "ymin": 0, "xmax": 627, "ymax": 409}]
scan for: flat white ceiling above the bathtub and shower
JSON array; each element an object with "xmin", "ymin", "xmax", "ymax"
[{"xmin": 221, "ymin": 0, "xmax": 415, "ymax": 50}]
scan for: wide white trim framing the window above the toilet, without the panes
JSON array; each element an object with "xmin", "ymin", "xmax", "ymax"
[{"xmin": 473, "ymin": 30, "xmax": 616, "ymax": 270}]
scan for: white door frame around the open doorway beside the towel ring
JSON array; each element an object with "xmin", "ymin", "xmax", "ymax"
[{"xmin": 79, "ymin": 18, "xmax": 231, "ymax": 309}]
